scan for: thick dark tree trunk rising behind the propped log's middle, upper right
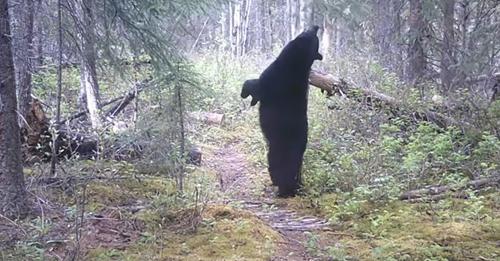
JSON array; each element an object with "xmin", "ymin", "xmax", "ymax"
[{"xmin": 406, "ymin": 0, "xmax": 425, "ymax": 88}]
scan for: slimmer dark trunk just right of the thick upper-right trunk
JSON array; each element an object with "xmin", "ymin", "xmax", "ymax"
[{"xmin": 441, "ymin": 0, "xmax": 455, "ymax": 93}]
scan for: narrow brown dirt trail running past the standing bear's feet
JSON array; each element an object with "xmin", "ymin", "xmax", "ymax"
[{"xmin": 204, "ymin": 144, "xmax": 328, "ymax": 260}]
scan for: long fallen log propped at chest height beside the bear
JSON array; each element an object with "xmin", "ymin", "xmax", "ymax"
[{"xmin": 309, "ymin": 70, "xmax": 473, "ymax": 130}]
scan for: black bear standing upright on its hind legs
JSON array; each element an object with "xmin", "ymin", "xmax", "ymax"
[{"xmin": 241, "ymin": 26, "xmax": 323, "ymax": 197}]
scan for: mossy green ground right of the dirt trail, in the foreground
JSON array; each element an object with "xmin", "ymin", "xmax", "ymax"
[{"xmin": 281, "ymin": 192, "xmax": 500, "ymax": 260}]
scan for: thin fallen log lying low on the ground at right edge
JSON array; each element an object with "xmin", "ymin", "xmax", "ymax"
[{"xmin": 399, "ymin": 175, "xmax": 500, "ymax": 201}]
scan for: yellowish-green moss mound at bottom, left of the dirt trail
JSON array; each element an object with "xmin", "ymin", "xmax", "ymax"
[{"xmin": 86, "ymin": 206, "xmax": 281, "ymax": 260}]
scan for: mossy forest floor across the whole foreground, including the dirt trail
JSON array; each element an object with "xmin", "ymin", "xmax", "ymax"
[{"xmin": 0, "ymin": 111, "xmax": 500, "ymax": 260}]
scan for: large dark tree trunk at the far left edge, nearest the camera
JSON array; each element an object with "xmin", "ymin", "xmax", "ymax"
[{"xmin": 0, "ymin": 0, "xmax": 29, "ymax": 218}]
